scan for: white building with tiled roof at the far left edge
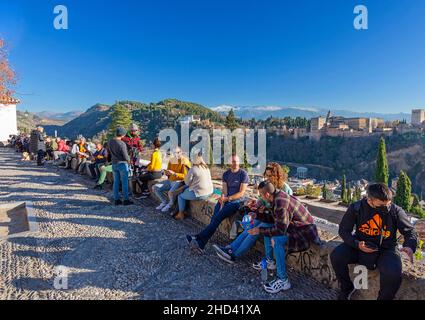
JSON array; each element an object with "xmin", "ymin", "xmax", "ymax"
[{"xmin": 0, "ymin": 95, "xmax": 20, "ymax": 144}]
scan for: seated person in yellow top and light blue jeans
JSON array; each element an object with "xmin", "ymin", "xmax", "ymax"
[{"xmin": 153, "ymin": 147, "xmax": 190, "ymax": 212}]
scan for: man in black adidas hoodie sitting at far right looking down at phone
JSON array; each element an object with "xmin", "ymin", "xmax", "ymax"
[{"xmin": 331, "ymin": 184, "xmax": 417, "ymax": 300}]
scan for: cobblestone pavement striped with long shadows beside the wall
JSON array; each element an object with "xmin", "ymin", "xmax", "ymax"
[{"xmin": 0, "ymin": 148, "xmax": 335, "ymax": 300}]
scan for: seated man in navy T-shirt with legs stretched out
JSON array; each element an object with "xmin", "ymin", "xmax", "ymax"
[{"xmin": 186, "ymin": 155, "xmax": 249, "ymax": 254}]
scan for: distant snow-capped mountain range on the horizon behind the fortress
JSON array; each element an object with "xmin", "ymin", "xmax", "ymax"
[{"xmin": 211, "ymin": 105, "xmax": 411, "ymax": 122}]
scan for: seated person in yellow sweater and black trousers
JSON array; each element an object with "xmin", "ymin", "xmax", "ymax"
[{"xmin": 136, "ymin": 138, "xmax": 162, "ymax": 199}]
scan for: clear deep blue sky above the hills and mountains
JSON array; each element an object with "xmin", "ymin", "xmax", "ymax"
[{"xmin": 0, "ymin": 0, "xmax": 425, "ymax": 113}]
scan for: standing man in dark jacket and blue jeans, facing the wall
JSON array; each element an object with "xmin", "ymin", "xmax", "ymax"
[{"xmin": 108, "ymin": 127, "xmax": 133, "ymax": 206}]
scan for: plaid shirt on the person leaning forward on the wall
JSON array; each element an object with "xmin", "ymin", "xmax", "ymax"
[{"xmin": 260, "ymin": 191, "xmax": 320, "ymax": 252}]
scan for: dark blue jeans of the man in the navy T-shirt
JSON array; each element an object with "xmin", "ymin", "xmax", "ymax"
[{"xmin": 196, "ymin": 200, "xmax": 240, "ymax": 249}]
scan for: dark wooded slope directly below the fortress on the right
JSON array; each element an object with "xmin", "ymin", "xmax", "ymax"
[{"xmin": 267, "ymin": 133, "xmax": 425, "ymax": 194}]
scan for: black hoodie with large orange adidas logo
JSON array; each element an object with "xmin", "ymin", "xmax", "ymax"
[{"xmin": 339, "ymin": 199, "xmax": 418, "ymax": 252}]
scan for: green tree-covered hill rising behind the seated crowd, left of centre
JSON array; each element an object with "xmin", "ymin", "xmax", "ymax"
[{"xmin": 45, "ymin": 99, "xmax": 223, "ymax": 140}]
